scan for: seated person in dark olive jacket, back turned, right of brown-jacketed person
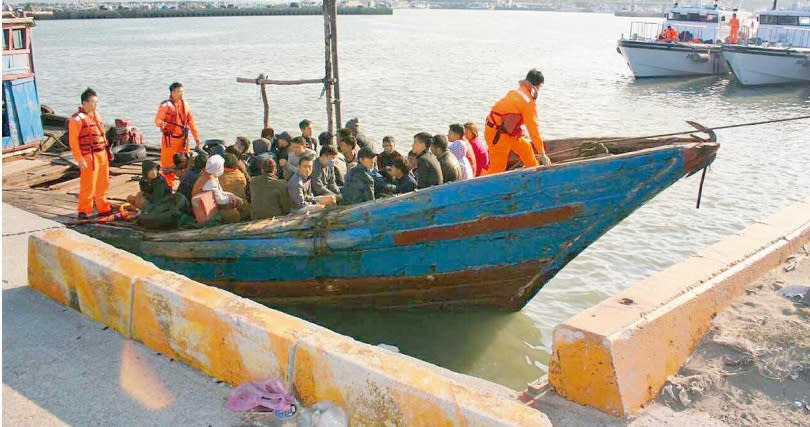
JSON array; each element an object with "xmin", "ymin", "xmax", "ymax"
[{"xmin": 250, "ymin": 157, "xmax": 292, "ymax": 220}]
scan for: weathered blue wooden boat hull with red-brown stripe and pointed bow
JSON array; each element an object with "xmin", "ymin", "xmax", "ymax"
[{"xmin": 83, "ymin": 133, "xmax": 719, "ymax": 310}]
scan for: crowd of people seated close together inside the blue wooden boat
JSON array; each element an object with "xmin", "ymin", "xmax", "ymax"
[{"xmin": 129, "ymin": 119, "xmax": 489, "ymax": 229}]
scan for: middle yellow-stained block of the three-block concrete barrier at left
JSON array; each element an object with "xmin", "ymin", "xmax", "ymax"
[{"xmin": 132, "ymin": 272, "xmax": 319, "ymax": 385}]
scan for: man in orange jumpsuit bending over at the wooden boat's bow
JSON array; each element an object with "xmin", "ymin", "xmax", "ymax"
[{"xmin": 484, "ymin": 69, "xmax": 551, "ymax": 175}]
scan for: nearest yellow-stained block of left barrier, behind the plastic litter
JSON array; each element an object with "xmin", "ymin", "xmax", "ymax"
[{"xmin": 294, "ymin": 333, "xmax": 551, "ymax": 426}]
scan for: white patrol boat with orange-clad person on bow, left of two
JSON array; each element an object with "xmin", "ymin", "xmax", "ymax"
[{"xmin": 616, "ymin": 3, "xmax": 755, "ymax": 77}]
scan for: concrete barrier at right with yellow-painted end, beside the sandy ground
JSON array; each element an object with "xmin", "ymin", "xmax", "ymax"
[{"xmin": 548, "ymin": 200, "xmax": 810, "ymax": 416}]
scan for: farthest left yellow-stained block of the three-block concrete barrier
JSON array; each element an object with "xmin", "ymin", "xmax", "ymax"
[{"xmin": 28, "ymin": 230, "xmax": 158, "ymax": 336}]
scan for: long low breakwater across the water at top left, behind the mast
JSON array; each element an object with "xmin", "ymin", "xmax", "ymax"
[{"xmin": 36, "ymin": 7, "xmax": 394, "ymax": 21}]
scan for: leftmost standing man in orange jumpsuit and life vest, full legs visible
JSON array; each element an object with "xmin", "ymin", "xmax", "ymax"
[{"xmin": 68, "ymin": 88, "xmax": 112, "ymax": 220}]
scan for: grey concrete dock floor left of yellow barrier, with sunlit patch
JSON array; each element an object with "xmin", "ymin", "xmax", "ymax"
[{"xmin": 3, "ymin": 203, "xmax": 241, "ymax": 426}]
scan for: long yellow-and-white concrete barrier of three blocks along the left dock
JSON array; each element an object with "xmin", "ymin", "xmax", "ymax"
[{"xmin": 29, "ymin": 230, "xmax": 550, "ymax": 426}]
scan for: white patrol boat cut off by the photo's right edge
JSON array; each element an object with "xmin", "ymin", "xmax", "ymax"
[{"xmin": 722, "ymin": 9, "xmax": 810, "ymax": 86}]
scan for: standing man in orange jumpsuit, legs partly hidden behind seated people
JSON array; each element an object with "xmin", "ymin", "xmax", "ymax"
[{"xmin": 155, "ymin": 82, "xmax": 200, "ymax": 188}]
